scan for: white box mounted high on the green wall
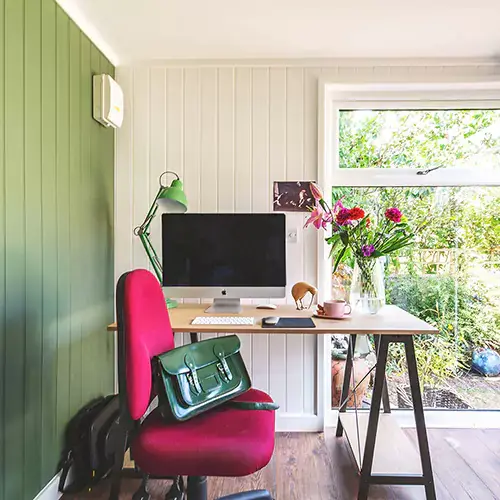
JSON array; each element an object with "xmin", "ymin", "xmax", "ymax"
[{"xmin": 93, "ymin": 75, "xmax": 123, "ymax": 128}]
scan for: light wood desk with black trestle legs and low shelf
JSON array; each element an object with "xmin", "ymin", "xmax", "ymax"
[{"xmin": 108, "ymin": 304, "xmax": 439, "ymax": 500}]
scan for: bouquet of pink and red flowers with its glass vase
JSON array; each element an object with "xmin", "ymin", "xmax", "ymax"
[{"xmin": 305, "ymin": 183, "xmax": 414, "ymax": 314}]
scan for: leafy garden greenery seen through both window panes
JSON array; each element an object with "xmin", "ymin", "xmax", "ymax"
[{"xmin": 332, "ymin": 110, "xmax": 500, "ymax": 408}]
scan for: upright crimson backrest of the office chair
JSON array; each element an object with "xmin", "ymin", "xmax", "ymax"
[{"xmin": 116, "ymin": 269, "xmax": 174, "ymax": 420}]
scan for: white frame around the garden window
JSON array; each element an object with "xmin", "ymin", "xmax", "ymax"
[{"xmin": 318, "ymin": 80, "xmax": 500, "ymax": 427}]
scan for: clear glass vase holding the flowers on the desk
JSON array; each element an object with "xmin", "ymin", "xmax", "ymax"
[{"xmin": 351, "ymin": 257, "xmax": 385, "ymax": 314}]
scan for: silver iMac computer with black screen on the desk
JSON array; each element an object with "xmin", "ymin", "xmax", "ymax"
[{"xmin": 162, "ymin": 214, "xmax": 286, "ymax": 313}]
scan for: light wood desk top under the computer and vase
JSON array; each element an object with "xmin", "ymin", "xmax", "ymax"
[{"xmin": 108, "ymin": 304, "xmax": 438, "ymax": 335}]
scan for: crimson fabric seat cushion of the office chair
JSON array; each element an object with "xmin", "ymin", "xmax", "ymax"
[{"xmin": 131, "ymin": 389, "xmax": 275, "ymax": 476}]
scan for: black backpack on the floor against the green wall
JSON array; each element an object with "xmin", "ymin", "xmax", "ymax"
[{"xmin": 58, "ymin": 395, "xmax": 120, "ymax": 493}]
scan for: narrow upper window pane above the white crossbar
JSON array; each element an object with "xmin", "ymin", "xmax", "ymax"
[{"xmin": 339, "ymin": 110, "xmax": 500, "ymax": 168}]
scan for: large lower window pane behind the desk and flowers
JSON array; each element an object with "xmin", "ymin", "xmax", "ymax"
[{"xmin": 332, "ymin": 187, "xmax": 500, "ymax": 409}]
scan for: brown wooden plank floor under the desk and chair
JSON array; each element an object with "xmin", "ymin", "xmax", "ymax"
[{"xmin": 64, "ymin": 429, "xmax": 500, "ymax": 500}]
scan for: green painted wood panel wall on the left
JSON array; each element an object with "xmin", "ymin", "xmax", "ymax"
[{"xmin": 0, "ymin": 0, "xmax": 114, "ymax": 500}]
